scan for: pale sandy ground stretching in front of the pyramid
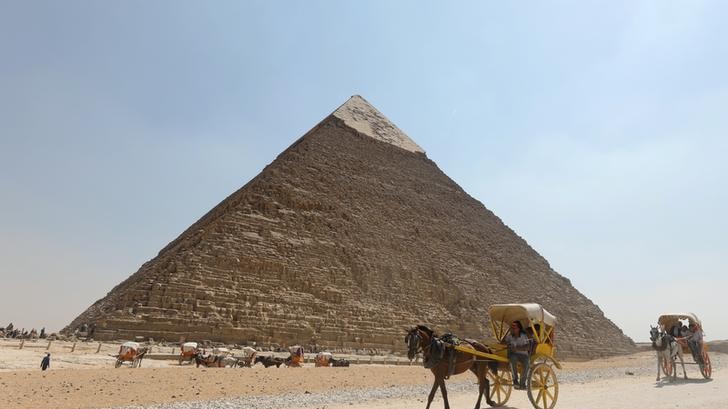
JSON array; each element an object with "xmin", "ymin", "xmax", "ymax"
[{"xmin": 0, "ymin": 343, "xmax": 728, "ymax": 409}]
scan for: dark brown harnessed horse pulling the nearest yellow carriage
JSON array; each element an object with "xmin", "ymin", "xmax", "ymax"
[{"xmin": 404, "ymin": 325, "xmax": 495, "ymax": 409}]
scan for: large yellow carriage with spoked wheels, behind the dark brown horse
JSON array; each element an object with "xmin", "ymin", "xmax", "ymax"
[{"xmin": 455, "ymin": 303, "xmax": 561, "ymax": 409}]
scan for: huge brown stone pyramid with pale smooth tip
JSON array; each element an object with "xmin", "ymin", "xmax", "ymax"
[{"xmin": 65, "ymin": 96, "xmax": 634, "ymax": 357}]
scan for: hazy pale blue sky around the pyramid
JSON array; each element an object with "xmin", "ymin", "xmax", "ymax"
[{"xmin": 0, "ymin": 0, "xmax": 728, "ymax": 341}]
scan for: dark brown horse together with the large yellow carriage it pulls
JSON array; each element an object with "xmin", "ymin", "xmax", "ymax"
[{"xmin": 405, "ymin": 303, "xmax": 561, "ymax": 409}]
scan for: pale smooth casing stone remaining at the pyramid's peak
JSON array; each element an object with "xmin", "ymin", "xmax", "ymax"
[{"xmin": 332, "ymin": 95, "xmax": 425, "ymax": 153}]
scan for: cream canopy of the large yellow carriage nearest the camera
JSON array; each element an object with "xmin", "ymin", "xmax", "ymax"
[{"xmin": 489, "ymin": 303, "xmax": 557, "ymax": 343}]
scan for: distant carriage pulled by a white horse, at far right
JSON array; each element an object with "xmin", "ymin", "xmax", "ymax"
[{"xmin": 650, "ymin": 312, "xmax": 712, "ymax": 380}]
